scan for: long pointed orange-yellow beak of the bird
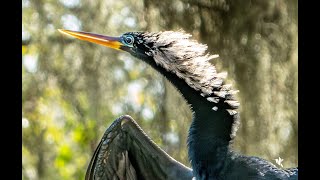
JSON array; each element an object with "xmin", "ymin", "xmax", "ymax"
[{"xmin": 58, "ymin": 29, "xmax": 124, "ymax": 50}]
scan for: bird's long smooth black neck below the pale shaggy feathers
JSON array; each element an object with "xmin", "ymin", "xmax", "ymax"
[{"xmin": 140, "ymin": 54, "xmax": 234, "ymax": 179}]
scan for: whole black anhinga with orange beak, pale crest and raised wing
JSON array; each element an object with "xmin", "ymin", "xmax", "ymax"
[{"xmin": 59, "ymin": 30, "xmax": 298, "ymax": 180}]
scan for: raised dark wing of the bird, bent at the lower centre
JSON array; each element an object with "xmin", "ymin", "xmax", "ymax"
[{"xmin": 85, "ymin": 115, "xmax": 193, "ymax": 180}]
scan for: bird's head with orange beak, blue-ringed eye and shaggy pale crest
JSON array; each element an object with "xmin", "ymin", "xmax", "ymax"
[{"xmin": 59, "ymin": 29, "xmax": 222, "ymax": 95}]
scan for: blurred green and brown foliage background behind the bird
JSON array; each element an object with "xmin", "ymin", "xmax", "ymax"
[{"xmin": 22, "ymin": 0, "xmax": 298, "ymax": 180}]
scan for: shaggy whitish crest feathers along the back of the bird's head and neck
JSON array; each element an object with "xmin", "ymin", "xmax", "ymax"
[{"xmin": 144, "ymin": 31, "xmax": 240, "ymax": 115}]
